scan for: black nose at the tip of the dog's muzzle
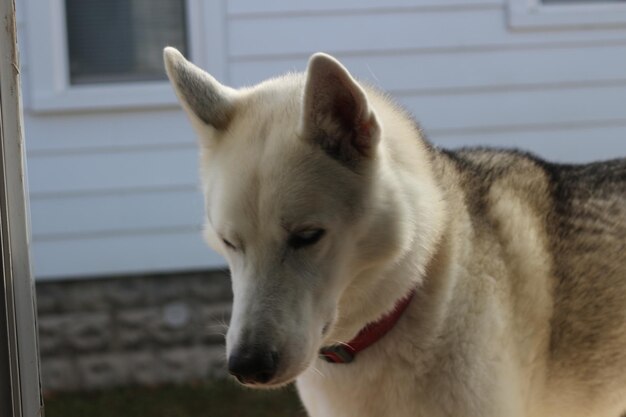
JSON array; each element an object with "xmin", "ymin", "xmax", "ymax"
[{"xmin": 228, "ymin": 348, "xmax": 278, "ymax": 384}]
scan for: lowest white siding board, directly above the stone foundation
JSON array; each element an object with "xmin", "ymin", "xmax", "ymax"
[{"xmin": 32, "ymin": 231, "xmax": 225, "ymax": 279}]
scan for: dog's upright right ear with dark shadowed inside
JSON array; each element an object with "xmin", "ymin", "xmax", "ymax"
[{"xmin": 300, "ymin": 53, "xmax": 380, "ymax": 164}]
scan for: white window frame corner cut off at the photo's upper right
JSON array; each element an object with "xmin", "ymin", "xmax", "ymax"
[{"xmin": 507, "ymin": 0, "xmax": 626, "ymax": 30}]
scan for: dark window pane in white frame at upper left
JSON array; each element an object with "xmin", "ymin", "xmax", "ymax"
[{"xmin": 65, "ymin": 0, "xmax": 187, "ymax": 84}]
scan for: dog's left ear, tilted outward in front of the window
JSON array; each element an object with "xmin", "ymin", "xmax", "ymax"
[{"xmin": 163, "ymin": 46, "xmax": 236, "ymax": 130}]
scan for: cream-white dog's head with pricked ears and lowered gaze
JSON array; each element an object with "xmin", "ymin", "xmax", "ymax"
[{"xmin": 165, "ymin": 48, "xmax": 414, "ymax": 386}]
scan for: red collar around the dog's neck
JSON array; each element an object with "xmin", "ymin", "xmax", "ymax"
[{"xmin": 319, "ymin": 290, "xmax": 415, "ymax": 363}]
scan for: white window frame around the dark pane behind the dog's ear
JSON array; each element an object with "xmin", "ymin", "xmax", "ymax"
[{"xmin": 24, "ymin": 0, "xmax": 226, "ymax": 113}]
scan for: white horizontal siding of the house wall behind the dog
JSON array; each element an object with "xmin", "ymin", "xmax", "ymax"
[{"xmin": 18, "ymin": 0, "xmax": 626, "ymax": 278}]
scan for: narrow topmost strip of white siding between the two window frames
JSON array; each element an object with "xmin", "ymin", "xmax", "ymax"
[{"xmin": 227, "ymin": 0, "xmax": 503, "ymax": 17}]
